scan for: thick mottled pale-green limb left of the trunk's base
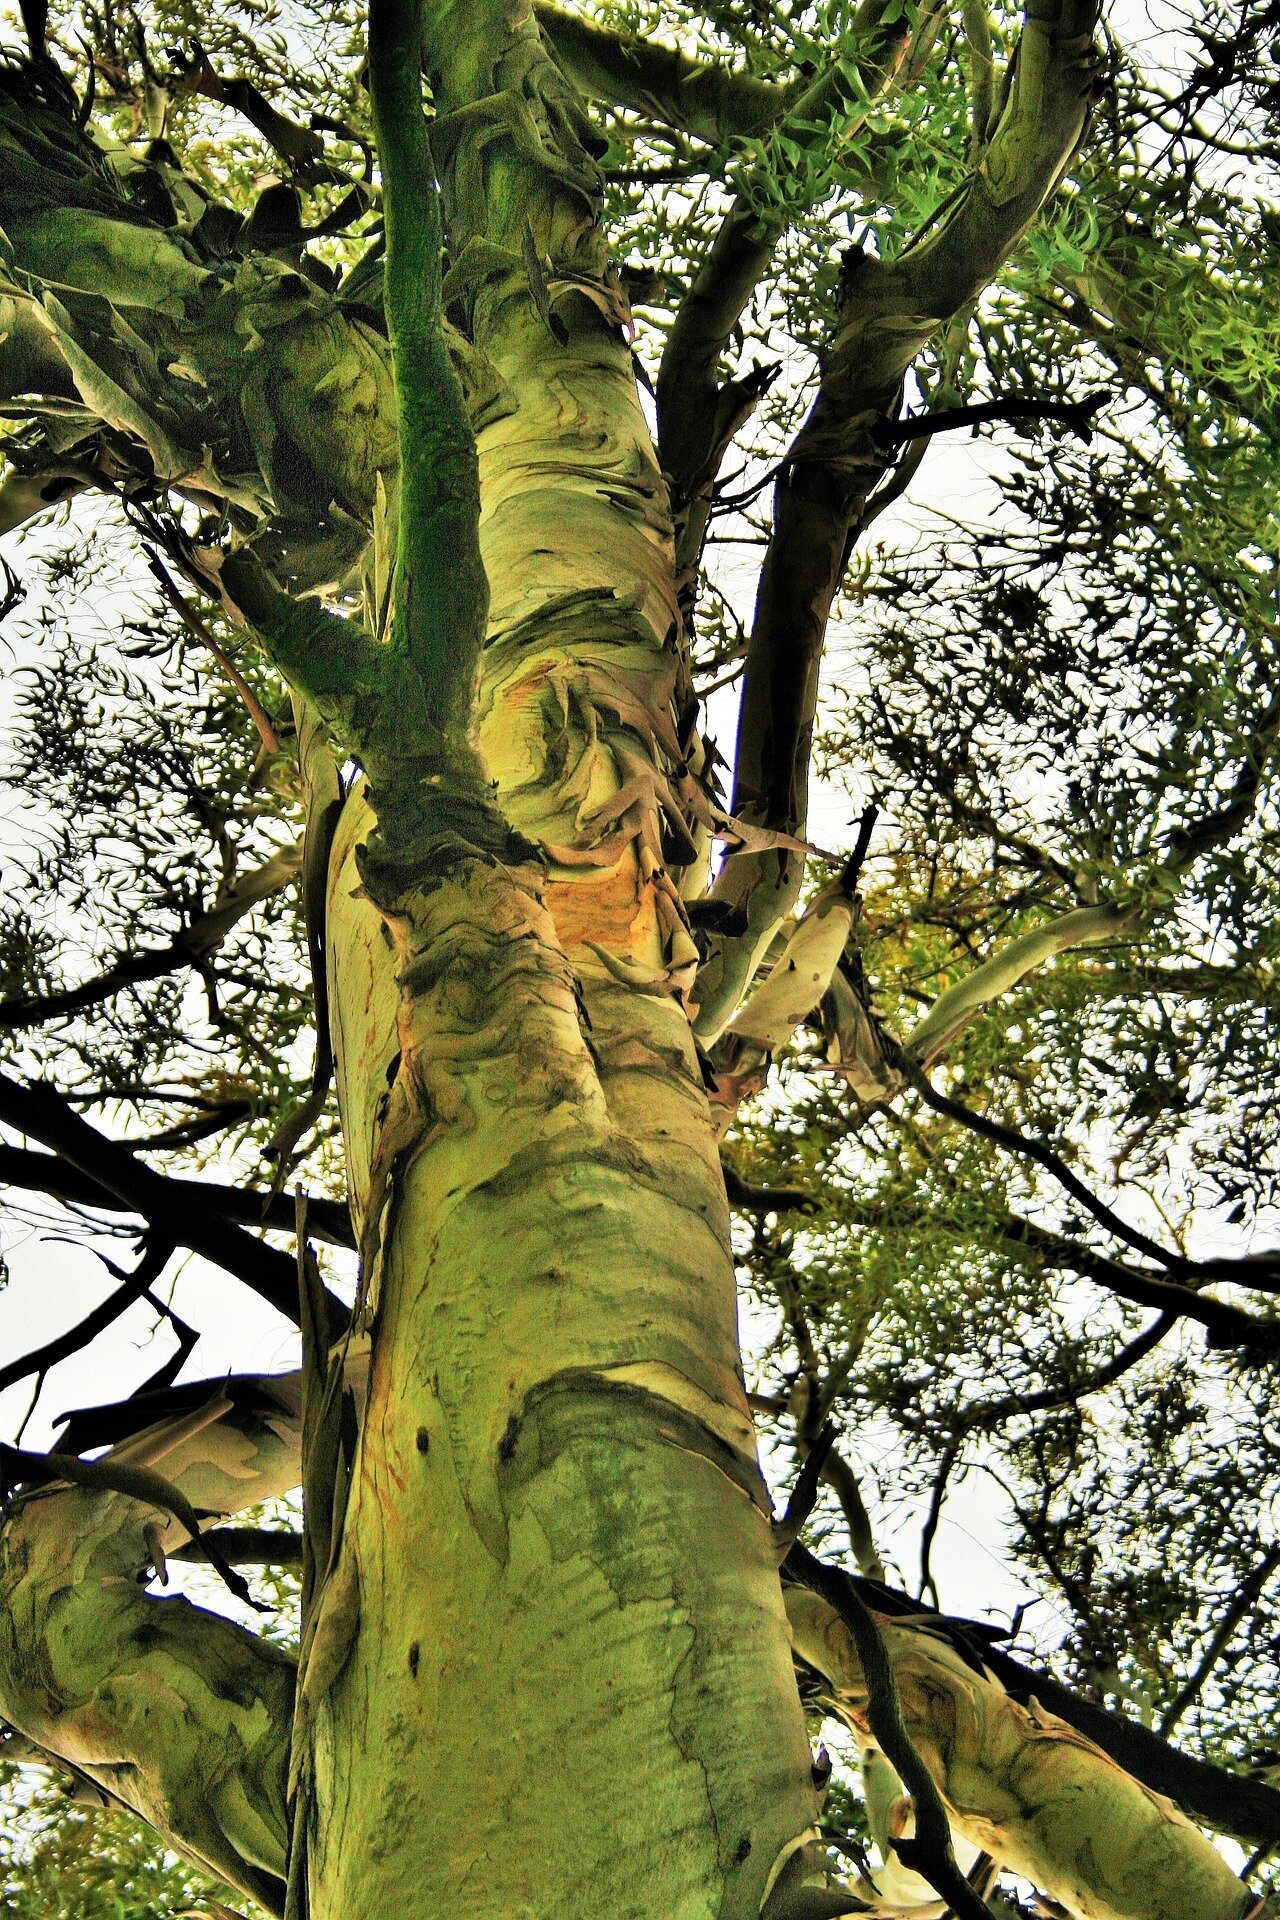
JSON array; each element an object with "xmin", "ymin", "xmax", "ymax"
[{"xmin": 0, "ymin": 1467, "xmax": 294, "ymax": 1912}]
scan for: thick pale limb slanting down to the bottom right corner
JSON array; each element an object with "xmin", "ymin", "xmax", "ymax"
[{"xmin": 787, "ymin": 1588, "xmax": 1257, "ymax": 1920}]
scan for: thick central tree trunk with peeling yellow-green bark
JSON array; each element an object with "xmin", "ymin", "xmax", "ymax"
[{"xmin": 282, "ymin": 6, "xmax": 816, "ymax": 1920}]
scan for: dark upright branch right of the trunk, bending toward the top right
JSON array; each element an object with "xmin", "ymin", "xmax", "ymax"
[{"xmin": 697, "ymin": 0, "xmax": 1096, "ymax": 1043}]
